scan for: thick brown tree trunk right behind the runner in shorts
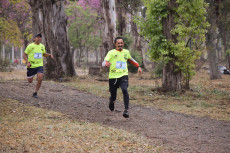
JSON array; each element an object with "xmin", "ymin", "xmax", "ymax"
[{"xmin": 29, "ymin": 0, "xmax": 76, "ymax": 79}]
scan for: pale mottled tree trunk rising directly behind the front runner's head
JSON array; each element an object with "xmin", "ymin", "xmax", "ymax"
[{"xmin": 101, "ymin": 0, "xmax": 117, "ymax": 58}]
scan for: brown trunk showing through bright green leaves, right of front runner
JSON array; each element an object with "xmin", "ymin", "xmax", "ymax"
[{"xmin": 162, "ymin": 0, "xmax": 182, "ymax": 92}]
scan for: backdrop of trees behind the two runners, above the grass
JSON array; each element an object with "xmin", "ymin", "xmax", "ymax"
[{"xmin": 0, "ymin": 0, "xmax": 230, "ymax": 92}]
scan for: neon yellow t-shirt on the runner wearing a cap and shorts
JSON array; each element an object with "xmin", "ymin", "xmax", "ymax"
[{"xmin": 25, "ymin": 43, "xmax": 46, "ymax": 68}]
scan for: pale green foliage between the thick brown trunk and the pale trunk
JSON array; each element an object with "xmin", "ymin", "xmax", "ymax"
[{"xmin": 66, "ymin": 2, "xmax": 101, "ymax": 48}]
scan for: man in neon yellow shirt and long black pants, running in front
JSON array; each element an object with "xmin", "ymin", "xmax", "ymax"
[{"xmin": 102, "ymin": 37, "xmax": 142, "ymax": 118}]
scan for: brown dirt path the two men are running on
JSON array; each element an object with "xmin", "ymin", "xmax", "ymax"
[{"xmin": 0, "ymin": 81, "xmax": 230, "ymax": 153}]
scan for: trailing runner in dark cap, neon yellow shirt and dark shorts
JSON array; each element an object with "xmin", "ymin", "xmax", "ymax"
[{"xmin": 23, "ymin": 34, "xmax": 53, "ymax": 98}]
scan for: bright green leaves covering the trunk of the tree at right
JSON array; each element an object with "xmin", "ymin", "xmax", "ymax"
[{"xmin": 136, "ymin": 0, "xmax": 208, "ymax": 79}]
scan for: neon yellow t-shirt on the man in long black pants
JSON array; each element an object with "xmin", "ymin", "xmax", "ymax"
[{"xmin": 105, "ymin": 49, "xmax": 132, "ymax": 79}]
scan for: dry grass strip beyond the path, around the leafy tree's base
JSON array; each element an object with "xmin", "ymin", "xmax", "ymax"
[{"xmin": 68, "ymin": 70, "xmax": 230, "ymax": 121}]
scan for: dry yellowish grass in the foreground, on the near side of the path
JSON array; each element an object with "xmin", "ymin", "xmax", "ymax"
[{"xmin": 0, "ymin": 97, "xmax": 165, "ymax": 152}]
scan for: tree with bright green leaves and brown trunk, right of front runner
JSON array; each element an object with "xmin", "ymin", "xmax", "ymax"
[{"xmin": 139, "ymin": 0, "xmax": 208, "ymax": 91}]
